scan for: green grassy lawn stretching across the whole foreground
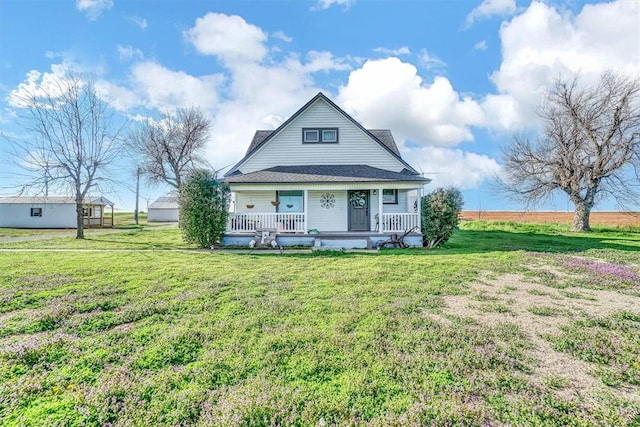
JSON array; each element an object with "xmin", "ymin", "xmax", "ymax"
[{"xmin": 0, "ymin": 222, "xmax": 640, "ymax": 426}]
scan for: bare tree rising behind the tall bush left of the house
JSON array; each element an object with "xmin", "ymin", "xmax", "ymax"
[{"xmin": 131, "ymin": 108, "xmax": 211, "ymax": 190}]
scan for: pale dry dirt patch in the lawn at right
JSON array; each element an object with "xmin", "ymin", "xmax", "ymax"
[{"xmin": 430, "ymin": 274, "xmax": 640, "ymax": 401}]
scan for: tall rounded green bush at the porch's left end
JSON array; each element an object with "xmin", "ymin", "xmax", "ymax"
[{"xmin": 180, "ymin": 169, "xmax": 229, "ymax": 248}]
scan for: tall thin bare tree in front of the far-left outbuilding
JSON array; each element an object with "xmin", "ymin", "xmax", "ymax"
[{"xmin": 8, "ymin": 69, "xmax": 125, "ymax": 239}]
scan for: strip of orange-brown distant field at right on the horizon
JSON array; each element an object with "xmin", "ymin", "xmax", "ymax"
[{"xmin": 460, "ymin": 211, "xmax": 640, "ymax": 226}]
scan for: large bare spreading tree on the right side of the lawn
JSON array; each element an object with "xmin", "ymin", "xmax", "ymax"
[{"xmin": 501, "ymin": 72, "xmax": 640, "ymax": 231}]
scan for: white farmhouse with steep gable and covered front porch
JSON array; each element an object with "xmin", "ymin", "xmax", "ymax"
[{"xmin": 222, "ymin": 93, "xmax": 430, "ymax": 248}]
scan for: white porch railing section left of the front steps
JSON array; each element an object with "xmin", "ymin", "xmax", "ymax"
[{"xmin": 227, "ymin": 213, "xmax": 305, "ymax": 233}]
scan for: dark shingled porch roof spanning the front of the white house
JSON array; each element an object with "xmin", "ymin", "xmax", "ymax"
[{"xmin": 224, "ymin": 165, "xmax": 431, "ymax": 184}]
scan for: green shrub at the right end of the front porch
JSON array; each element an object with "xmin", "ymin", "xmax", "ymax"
[{"xmin": 421, "ymin": 188, "xmax": 464, "ymax": 248}]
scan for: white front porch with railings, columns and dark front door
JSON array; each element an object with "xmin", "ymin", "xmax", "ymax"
[{"xmin": 222, "ymin": 181, "xmax": 422, "ymax": 249}]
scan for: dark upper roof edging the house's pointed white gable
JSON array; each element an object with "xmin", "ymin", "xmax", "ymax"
[{"xmin": 225, "ymin": 92, "xmax": 418, "ymax": 176}]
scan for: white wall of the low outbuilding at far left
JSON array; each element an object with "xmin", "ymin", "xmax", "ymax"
[{"xmin": 0, "ymin": 203, "xmax": 76, "ymax": 228}]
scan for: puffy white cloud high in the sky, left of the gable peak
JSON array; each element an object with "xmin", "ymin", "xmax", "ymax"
[{"xmin": 183, "ymin": 12, "xmax": 267, "ymax": 66}]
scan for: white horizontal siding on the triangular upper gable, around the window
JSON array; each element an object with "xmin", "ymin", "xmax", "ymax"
[{"xmin": 240, "ymin": 99, "xmax": 405, "ymax": 173}]
